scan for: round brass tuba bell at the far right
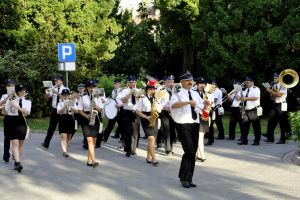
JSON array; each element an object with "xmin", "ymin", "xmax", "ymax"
[{"xmin": 279, "ymin": 69, "xmax": 299, "ymax": 88}]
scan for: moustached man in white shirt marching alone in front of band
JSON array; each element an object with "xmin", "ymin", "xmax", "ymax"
[{"xmin": 170, "ymin": 72, "xmax": 204, "ymax": 188}]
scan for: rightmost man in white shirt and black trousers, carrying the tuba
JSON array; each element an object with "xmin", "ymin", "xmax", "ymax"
[{"xmin": 265, "ymin": 73, "xmax": 290, "ymax": 144}]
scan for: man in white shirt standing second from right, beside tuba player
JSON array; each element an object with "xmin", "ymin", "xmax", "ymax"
[{"xmin": 237, "ymin": 77, "xmax": 261, "ymax": 146}]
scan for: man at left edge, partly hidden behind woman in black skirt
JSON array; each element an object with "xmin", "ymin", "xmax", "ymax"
[{"xmin": 0, "ymin": 79, "xmax": 15, "ymax": 162}]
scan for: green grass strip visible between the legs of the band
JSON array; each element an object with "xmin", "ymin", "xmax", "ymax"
[{"xmin": 0, "ymin": 113, "xmax": 280, "ymax": 135}]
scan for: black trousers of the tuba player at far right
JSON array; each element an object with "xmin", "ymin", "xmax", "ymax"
[{"xmin": 267, "ymin": 103, "xmax": 290, "ymax": 142}]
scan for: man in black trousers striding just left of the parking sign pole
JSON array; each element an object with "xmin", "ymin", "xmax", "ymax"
[{"xmin": 41, "ymin": 76, "xmax": 66, "ymax": 149}]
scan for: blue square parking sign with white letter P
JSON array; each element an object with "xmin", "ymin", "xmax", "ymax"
[{"xmin": 57, "ymin": 43, "xmax": 76, "ymax": 62}]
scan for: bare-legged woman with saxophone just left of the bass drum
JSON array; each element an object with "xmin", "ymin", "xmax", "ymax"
[{"xmin": 78, "ymin": 80, "xmax": 103, "ymax": 167}]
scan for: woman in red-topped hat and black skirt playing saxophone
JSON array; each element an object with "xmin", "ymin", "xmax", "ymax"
[{"xmin": 136, "ymin": 80, "xmax": 162, "ymax": 166}]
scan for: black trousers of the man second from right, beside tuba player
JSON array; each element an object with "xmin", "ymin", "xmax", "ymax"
[{"xmin": 241, "ymin": 111, "xmax": 261, "ymax": 143}]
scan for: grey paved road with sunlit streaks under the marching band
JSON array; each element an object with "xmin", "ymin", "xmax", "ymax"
[{"xmin": 0, "ymin": 132, "xmax": 300, "ymax": 200}]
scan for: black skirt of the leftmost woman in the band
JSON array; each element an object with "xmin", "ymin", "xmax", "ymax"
[{"xmin": 4, "ymin": 116, "xmax": 27, "ymax": 140}]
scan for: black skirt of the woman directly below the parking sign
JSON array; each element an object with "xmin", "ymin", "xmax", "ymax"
[{"xmin": 58, "ymin": 114, "xmax": 75, "ymax": 134}]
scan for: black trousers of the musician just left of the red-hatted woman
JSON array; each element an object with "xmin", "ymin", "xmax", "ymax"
[{"xmin": 122, "ymin": 110, "xmax": 139, "ymax": 154}]
